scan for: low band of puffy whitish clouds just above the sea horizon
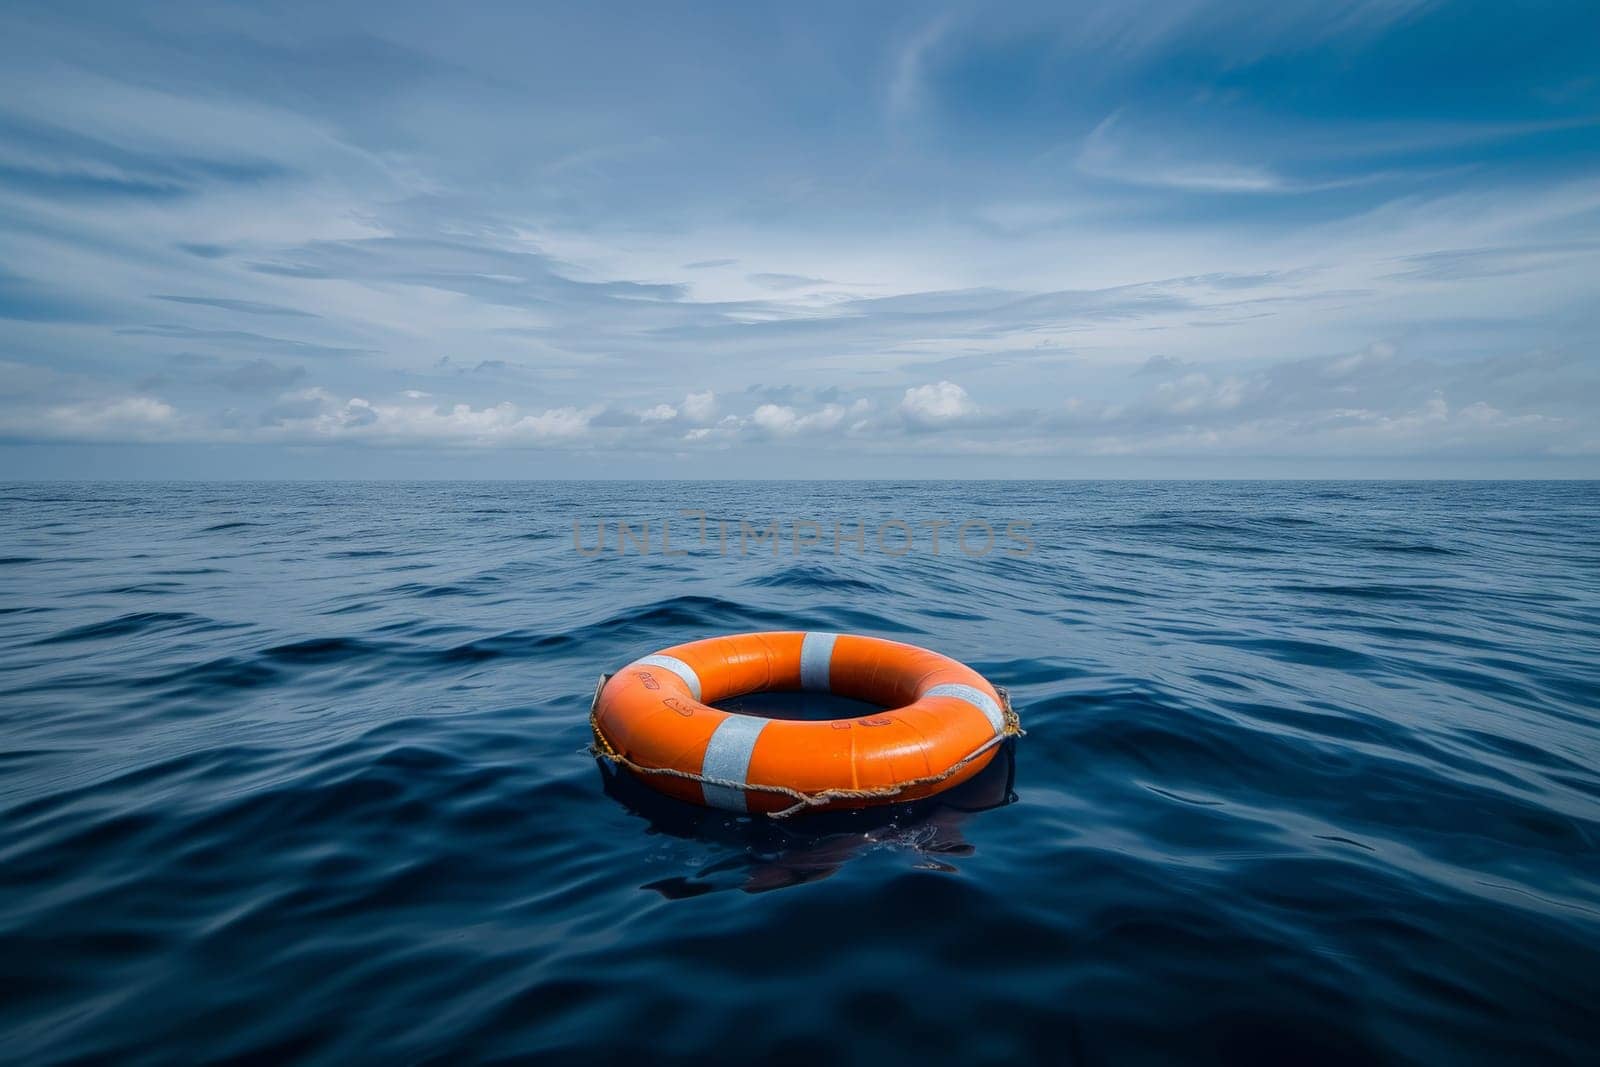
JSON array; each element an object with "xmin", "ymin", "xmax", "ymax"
[{"xmin": 0, "ymin": 344, "xmax": 1600, "ymax": 461}]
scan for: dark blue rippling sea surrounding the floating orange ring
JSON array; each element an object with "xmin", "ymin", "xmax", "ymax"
[{"xmin": 0, "ymin": 483, "xmax": 1600, "ymax": 1064}]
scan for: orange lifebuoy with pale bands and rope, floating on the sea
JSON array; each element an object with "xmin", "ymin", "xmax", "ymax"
[{"xmin": 592, "ymin": 632, "xmax": 1021, "ymax": 814}]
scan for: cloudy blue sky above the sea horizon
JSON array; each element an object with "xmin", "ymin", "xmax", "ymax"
[{"xmin": 0, "ymin": 0, "xmax": 1600, "ymax": 478}]
